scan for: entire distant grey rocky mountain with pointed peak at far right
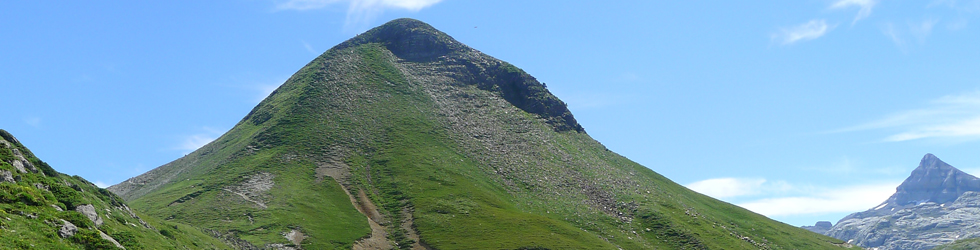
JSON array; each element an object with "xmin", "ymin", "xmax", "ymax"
[{"xmin": 827, "ymin": 154, "xmax": 980, "ymax": 250}]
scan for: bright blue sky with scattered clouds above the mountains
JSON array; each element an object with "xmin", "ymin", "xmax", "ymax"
[{"xmin": 0, "ymin": 0, "xmax": 980, "ymax": 226}]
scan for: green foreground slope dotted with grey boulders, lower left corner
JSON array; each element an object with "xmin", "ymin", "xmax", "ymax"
[{"xmin": 0, "ymin": 130, "xmax": 230, "ymax": 249}]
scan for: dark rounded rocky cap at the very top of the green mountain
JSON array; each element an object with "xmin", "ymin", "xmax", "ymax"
[{"xmin": 334, "ymin": 18, "xmax": 470, "ymax": 61}]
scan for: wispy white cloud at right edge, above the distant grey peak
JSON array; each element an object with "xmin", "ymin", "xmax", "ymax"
[{"xmin": 832, "ymin": 91, "xmax": 980, "ymax": 142}]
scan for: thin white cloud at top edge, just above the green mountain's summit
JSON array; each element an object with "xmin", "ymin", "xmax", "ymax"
[{"xmin": 276, "ymin": 0, "xmax": 442, "ymax": 30}]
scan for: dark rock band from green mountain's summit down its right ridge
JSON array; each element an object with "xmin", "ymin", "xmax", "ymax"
[{"xmin": 330, "ymin": 18, "xmax": 585, "ymax": 132}]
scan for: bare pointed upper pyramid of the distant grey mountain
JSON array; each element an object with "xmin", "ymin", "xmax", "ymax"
[{"xmin": 888, "ymin": 154, "xmax": 980, "ymax": 206}]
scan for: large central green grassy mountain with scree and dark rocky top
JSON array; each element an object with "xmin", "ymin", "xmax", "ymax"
[{"xmin": 110, "ymin": 19, "xmax": 856, "ymax": 249}]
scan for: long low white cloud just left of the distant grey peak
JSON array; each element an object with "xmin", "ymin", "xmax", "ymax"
[{"xmin": 737, "ymin": 183, "xmax": 899, "ymax": 217}]
